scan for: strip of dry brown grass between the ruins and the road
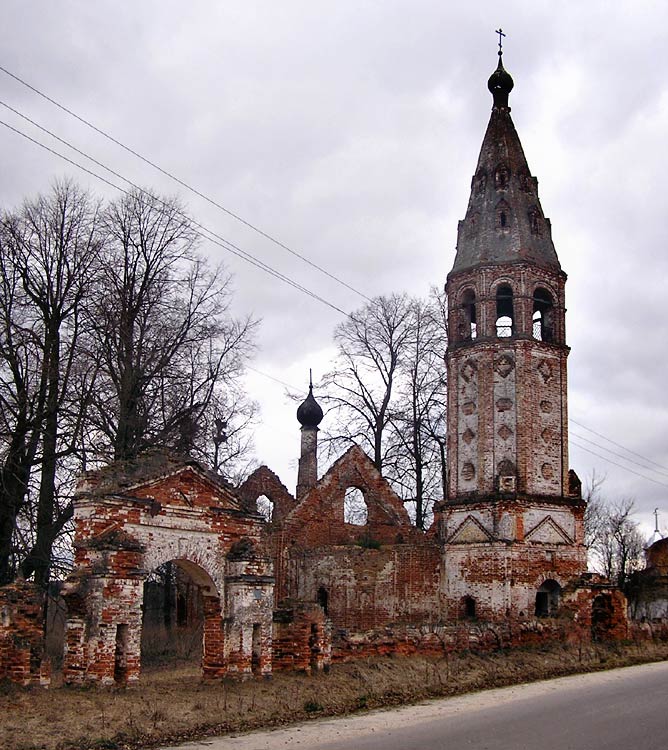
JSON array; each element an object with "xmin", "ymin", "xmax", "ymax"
[{"xmin": 0, "ymin": 643, "xmax": 668, "ymax": 750}]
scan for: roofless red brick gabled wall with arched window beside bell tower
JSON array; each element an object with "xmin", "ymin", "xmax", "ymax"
[{"xmin": 273, "ymin": 447, "xmax": 441, "ymax": 641}]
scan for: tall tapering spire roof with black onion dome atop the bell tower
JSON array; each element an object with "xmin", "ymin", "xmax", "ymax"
[{"xmin": 452, "ymin": 52, "xmax": 561, "ymax": 272}]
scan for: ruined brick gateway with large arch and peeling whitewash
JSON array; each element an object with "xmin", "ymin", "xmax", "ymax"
[{"xmin": 64, "ymin": 453, "xmax": 274, "ymax": 684}]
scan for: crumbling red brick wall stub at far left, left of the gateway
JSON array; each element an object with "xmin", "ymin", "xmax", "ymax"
[{"xmin": 0, "ymin": 582, "xmax": 51, "ymax": 687}]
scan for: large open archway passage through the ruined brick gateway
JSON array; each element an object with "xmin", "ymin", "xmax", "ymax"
[{"xmin": 142, "ymin": 558, "xmax": 223, "ymax": 681}]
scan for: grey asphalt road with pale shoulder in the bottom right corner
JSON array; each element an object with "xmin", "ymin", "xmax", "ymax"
[{"xmin": 162, "ymin": 662, "xmax": 668, "ymax": 750}]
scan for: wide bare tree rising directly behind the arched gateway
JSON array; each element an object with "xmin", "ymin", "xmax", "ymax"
[{"xmin": 91, "ymin": 190, "xmax": 256, "ymax": 465}]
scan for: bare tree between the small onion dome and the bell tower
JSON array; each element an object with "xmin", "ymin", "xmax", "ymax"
[{"xmin": 319, "ymin": 293, "xmax": 447, "ymax": 528}]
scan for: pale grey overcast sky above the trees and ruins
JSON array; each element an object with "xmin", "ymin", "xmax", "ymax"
[{"xmin": 0, "ymin": 0, "xmax": 668, "ymax": 532}]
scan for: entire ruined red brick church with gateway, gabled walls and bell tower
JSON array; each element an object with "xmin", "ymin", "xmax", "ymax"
[{"xmin": 0, "ymin": 45, "xmax": 648, "ymax": 684}]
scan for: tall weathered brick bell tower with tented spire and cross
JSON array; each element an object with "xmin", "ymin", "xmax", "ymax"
[{"xmin": 441, "ymin": 41, "xmax": 586, "ymax": 619}]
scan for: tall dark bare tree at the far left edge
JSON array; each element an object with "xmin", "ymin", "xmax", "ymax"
[{"xmin": 0, "ymin": 182, "xmax": 101, "ymax": 585}]
